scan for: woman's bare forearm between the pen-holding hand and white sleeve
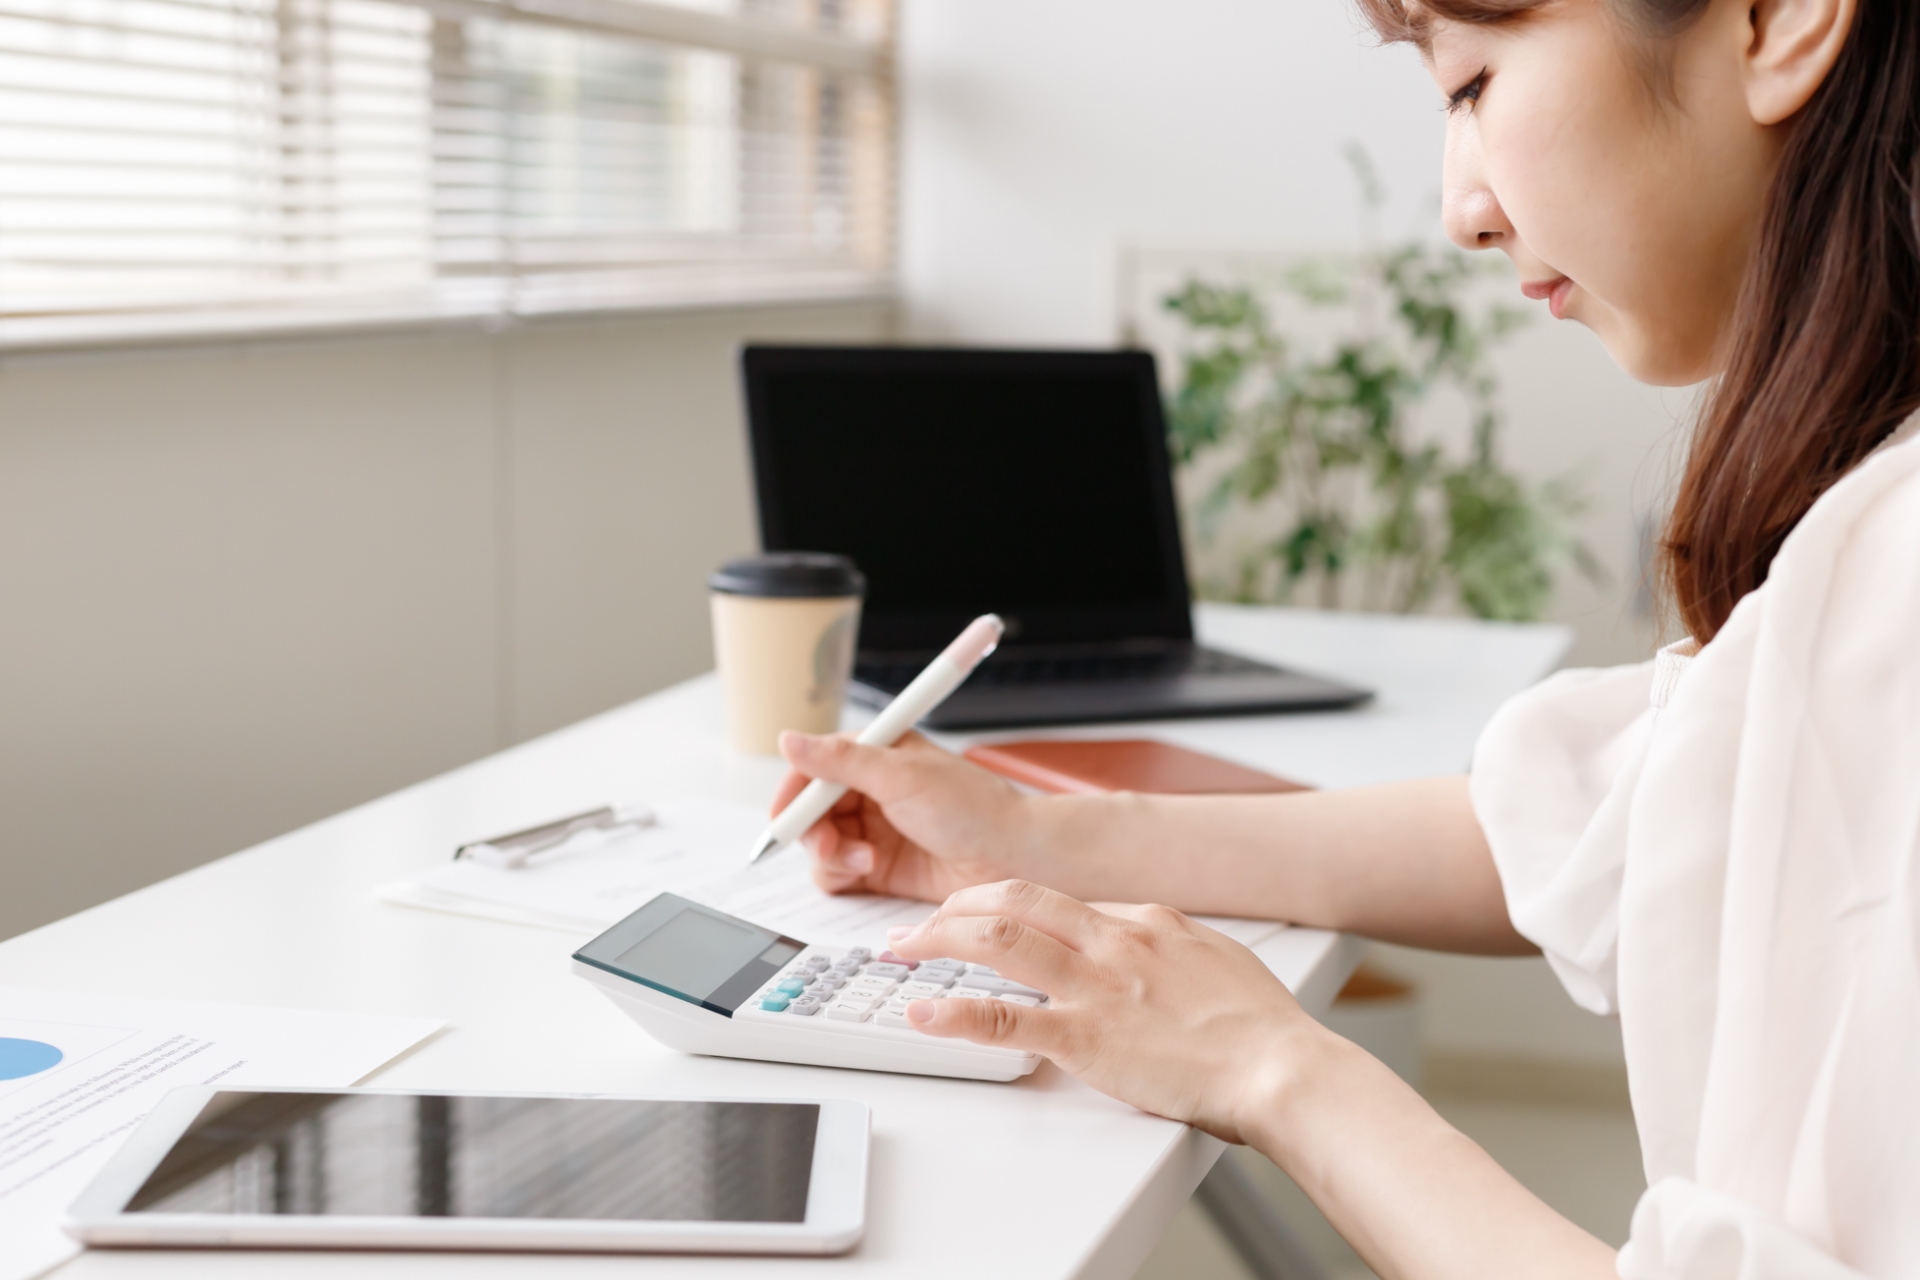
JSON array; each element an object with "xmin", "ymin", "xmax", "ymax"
[{"xmin": 1031, "ymin": 777, "xmax": 1534, "ymax": 956}]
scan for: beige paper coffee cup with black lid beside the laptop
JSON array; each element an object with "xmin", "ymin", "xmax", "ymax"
[{"xmin": 707, "ymin": 551, "xmax": 866, "ymax": 756}]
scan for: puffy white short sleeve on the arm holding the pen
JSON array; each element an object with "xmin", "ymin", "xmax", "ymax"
[{"xmin": 1471, "ymin": 662, "xmax": 1653, "ymax": 1013}]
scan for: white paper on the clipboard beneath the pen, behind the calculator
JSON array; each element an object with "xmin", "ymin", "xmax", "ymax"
[{"xmin": 374, "ymin": 804, "xmax": 1284, "ymax": 946}]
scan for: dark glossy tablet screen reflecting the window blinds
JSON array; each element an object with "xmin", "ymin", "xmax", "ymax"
[{"xmin": 127, "ymin": 1092, "xmax": 820, "ymax": 1222}]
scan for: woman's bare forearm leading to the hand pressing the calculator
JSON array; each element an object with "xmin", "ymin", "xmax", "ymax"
[{"xmin": 1240, "ymin": 1025, "xmax": 1619, "ymax": 1280}]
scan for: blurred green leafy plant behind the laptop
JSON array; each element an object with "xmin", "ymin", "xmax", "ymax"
[{"xmin": 1162, "ymin": 244, "xmax": 1601, "ymax": 620}]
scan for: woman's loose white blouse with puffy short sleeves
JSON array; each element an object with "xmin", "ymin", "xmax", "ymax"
[{"xmin": 1473, "ymin": 415, "xmax": 1920, "ymax": 1280}]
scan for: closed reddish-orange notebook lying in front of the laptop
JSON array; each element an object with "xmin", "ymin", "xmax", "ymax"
[{"xmin": 966, "ymin": 737, "xmax": 1308, "ymax": 794}]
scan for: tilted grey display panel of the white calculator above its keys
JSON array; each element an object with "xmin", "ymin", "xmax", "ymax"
[{"xmin": 576, "ymin": 894, "xmax": 806, "ymax": 1017}]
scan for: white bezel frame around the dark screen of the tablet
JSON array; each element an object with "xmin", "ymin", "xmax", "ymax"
[{"xmin": 61, "ymin": 1086, "xmax": 872, "ymax": 1253}]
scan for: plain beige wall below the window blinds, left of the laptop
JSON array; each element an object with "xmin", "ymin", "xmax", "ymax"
[{"xmin": 0, "ymin": 303, "xmax": 891, "ymax": 936}]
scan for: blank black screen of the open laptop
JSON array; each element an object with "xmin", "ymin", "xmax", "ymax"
[{"xmin": 743, "ymin": 347, "xmax": 1190, "ymax": 651}]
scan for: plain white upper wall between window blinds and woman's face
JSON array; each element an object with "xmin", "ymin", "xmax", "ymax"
[{"xmin": 900, "ymin": 0, "xmax": 1442, "ymax": 344}]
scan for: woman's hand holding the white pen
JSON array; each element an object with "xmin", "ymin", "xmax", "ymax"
[{"xmin": 772, "ymin": 731, "xmax": 1039, "ymax": 902}]
